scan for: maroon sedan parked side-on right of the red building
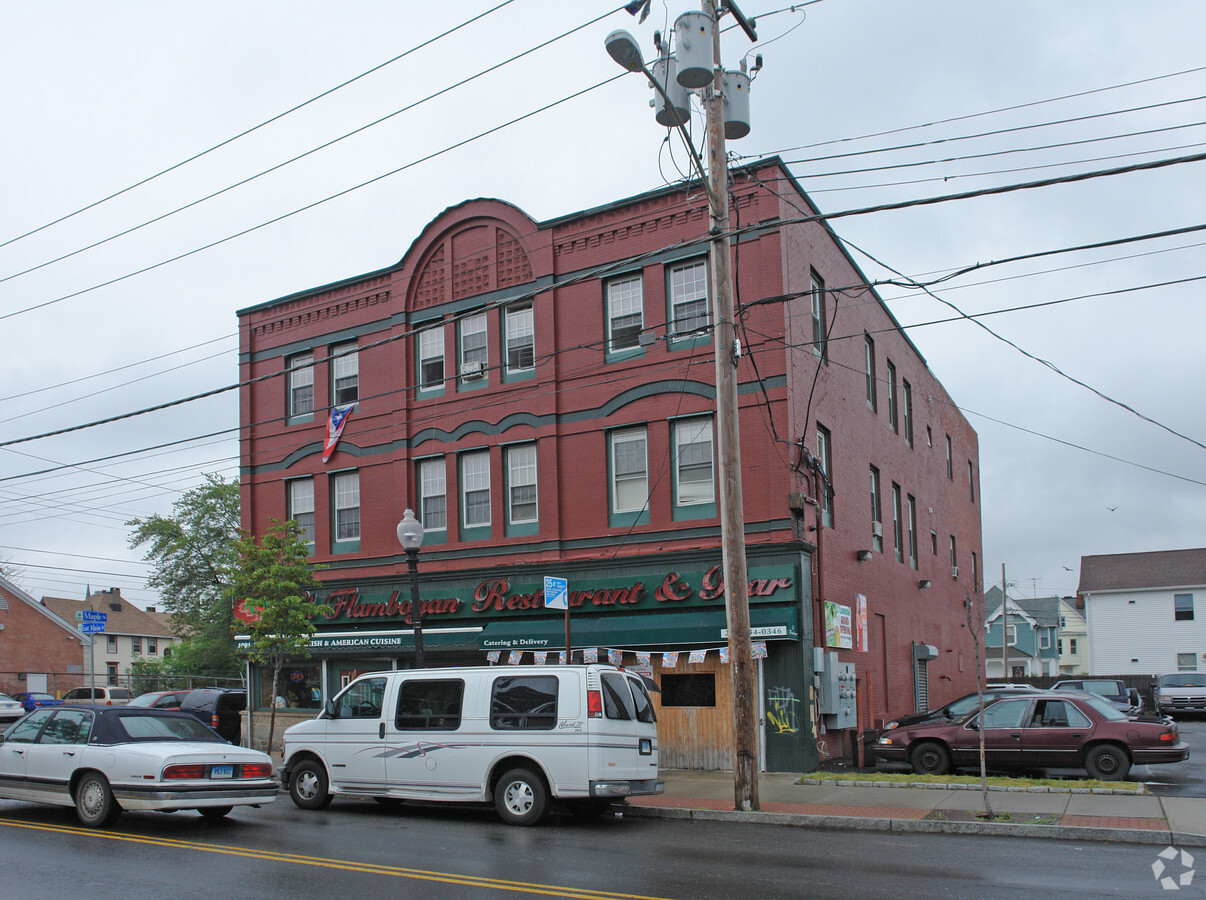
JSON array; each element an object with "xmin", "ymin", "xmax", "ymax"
[{"xmin": 876, "ymin": 691, "xmax": 1189, "ymax": 781}]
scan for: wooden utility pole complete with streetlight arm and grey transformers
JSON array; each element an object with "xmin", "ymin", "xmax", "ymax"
[{"xmin": 604, "ymin": 0, "xmax": 760, "ymax": 811}]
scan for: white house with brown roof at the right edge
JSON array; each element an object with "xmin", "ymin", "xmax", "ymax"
[{"xmin": 1078, "ymin": 548, "xmax": 1206, "ymax": 674}]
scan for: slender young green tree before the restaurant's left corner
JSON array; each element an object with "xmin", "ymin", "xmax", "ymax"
[{"xmin": 227, "ymin": 519, "xmax": 330, "ymax": 753}]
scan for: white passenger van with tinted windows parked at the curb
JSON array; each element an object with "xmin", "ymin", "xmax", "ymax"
[{"xmin": 280, "ymin": 665, "xmax": 665, "ymax": 825}]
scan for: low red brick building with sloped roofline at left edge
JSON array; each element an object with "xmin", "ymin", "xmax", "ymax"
[{"xmin": 0, "ymin": 577, "xmax": 86, "ymax": 694}]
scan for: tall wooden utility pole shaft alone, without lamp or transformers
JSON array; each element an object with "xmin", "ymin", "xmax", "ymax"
[{"xmin": 703, "ymin": 0, "xmax": 759, "ymax": 811}]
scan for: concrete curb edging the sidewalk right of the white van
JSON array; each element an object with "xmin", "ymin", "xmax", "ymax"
[{"xmin": 625, "ymin": 805, "xmax": 1206, "ymax": 847}]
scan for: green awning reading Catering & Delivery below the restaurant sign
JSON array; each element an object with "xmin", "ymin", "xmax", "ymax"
[{"xmin": 475, "ymin": 607, "xmax": 800, "ymax": 650}]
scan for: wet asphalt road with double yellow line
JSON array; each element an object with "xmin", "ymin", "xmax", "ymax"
[{"xmin": 0, "ymin": 795, "xmax": 1181, "ymax": 900}]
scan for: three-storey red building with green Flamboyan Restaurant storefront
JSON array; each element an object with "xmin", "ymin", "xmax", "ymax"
[{"xmin": 239, "ymin": 159, "xmax": 980, "ymax": 771}]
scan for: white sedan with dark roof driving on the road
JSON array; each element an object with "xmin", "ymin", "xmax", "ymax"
[{"xmin": 0, "ymin": 706, "xmax": 277, "ymax": 828}]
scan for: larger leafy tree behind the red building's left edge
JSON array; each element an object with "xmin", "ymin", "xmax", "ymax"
[{"xmin": 127, "ymin": 474, "xmax": 240, "ymax": 677}]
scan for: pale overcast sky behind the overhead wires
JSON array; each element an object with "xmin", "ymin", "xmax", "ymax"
[{"xmin": 0, "ymin": 0, "xmax": 1206, "ymax": 607}]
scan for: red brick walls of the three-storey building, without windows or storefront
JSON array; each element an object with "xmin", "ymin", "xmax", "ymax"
[{"xmin": 239, "ymin": 159, "xmax": 982, "ymax": 753}]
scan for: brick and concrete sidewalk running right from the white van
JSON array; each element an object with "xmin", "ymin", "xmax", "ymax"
[{"xmin": 628, "ymin": 770, "xmax": 1206, "ymax": 847}]
